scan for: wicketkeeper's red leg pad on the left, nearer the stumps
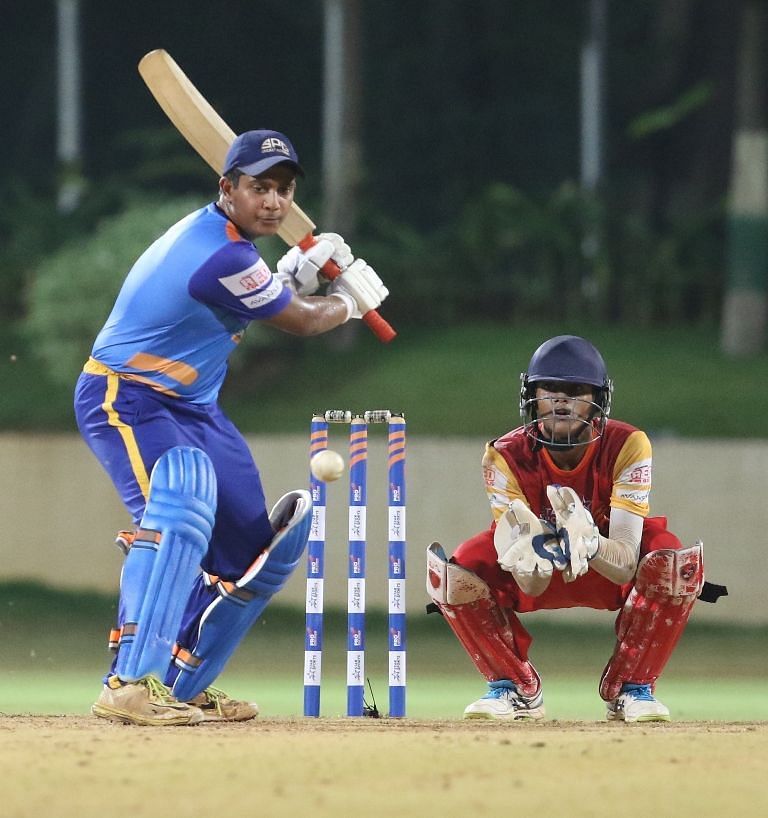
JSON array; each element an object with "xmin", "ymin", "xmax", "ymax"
[{"xmin": 427, "ymin": 543, "xmax": 541, "ymax": 696}]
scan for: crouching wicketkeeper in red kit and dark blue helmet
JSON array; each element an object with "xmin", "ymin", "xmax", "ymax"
[{"xmin": 427, "ymin": 335, "xmax": 724, "ymax": 722}]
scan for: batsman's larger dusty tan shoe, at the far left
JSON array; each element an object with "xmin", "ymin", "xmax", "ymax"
[{"xmin": 91, "ymin": 676, "xmax": 204, "ymax": 727}]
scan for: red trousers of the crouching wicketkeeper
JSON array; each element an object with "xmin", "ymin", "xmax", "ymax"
[{"xmin": 451, "ymin": 517, "xmax": 682, "ymax": 661}]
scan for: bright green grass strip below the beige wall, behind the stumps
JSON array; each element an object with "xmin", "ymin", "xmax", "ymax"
[{"xmin": 0, "ymin": 584, "xmax": 768, "ymax": 721}]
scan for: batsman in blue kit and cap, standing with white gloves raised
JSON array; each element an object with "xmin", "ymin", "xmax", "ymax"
[{"xmin": 75, "ymin": 130, "xmax": 388, "ymax": 725}]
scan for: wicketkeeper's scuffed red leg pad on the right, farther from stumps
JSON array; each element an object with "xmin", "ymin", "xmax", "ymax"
[{"xmin": 600, "ymin": 543, "xmax": 704, "ymax": 701}]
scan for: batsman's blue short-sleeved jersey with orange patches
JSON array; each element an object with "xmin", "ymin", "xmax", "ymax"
[{"xmin": 91, "ymin": 203, "xmax": 291, "ymax": 404}]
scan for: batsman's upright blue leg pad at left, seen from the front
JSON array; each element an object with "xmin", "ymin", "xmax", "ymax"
[{"xmin": 115, "ymin": 446, "xmax": 216, "ymax": 681}]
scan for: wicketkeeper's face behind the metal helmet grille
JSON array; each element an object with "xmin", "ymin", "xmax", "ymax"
[{"xmin": 536, "ymin": 381, "xmax": 597, "ymax": 445}]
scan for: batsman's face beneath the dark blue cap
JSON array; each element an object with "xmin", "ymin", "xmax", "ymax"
[{"xmin": 220, "ymin": 165, "xmax": 296, "ymax": 239}]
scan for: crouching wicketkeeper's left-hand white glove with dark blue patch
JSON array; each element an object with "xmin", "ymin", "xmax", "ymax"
[{"xmin": 493, "ymin": 500, "xmax": 562, "ymax": 596}]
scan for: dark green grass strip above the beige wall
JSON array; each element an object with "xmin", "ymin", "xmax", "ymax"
[{"xmin": 0, "ymin": 321, "xmax": 768, "ymax": 440}]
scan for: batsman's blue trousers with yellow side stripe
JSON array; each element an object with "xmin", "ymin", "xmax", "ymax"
[{"xmin": 75, "ymin": 366, "xmax": 273, "ymax": 681}]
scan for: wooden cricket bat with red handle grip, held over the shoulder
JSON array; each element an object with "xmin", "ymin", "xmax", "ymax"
[{"xmin": 139, "ymin": 48, "xmax": 397, "ymax": 343}]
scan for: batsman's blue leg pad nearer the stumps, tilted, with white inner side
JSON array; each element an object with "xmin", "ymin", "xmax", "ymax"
[{"xmin": 173, "ymin": 490, "xmax": 312, "ymax": 702}]
